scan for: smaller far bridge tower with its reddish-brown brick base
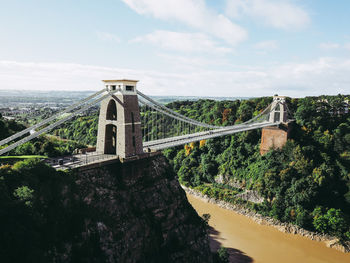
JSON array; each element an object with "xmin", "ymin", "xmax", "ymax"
[{"xmin": 260, "ymin": 96, "xmax": 290, "ymax": 155}]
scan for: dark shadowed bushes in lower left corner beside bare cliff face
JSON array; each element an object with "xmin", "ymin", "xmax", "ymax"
[{"xmin": 0, "ymin": 159, "xmax": 84, "ymax": 262}]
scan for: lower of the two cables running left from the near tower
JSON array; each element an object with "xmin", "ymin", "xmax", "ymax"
[{"xmin": 0, "ymin": 89, "xmax": 120, "ymax": 155}]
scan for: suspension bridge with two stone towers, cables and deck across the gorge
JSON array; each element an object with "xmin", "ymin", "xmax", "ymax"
[{"xmin": 0, "ymin": 79, "xmax": 289, "ymax": 167}]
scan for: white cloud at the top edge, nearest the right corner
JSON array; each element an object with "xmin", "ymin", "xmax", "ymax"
[{"xmin": 226, "ymin": 0, "xmax": 310, "ymax": 29}]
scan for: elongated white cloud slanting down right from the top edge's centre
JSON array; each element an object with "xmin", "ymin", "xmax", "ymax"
[{"xmin": 123, "ymin": 0, "xmax": 247, "ymax": 45}]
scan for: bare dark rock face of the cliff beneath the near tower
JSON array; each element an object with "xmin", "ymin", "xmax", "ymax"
[{"xmin": 52, "ymin": 155, "xmax": 212, "ymax": 262}]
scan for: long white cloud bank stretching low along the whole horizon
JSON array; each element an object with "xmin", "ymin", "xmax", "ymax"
[{"xmin": 0, "ymin": 58, "xmax": 350, "ymax": 97}]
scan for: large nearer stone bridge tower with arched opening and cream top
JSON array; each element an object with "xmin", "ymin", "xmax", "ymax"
[{"xmin": 96, "ymin": 79, "xmax": 143, "ymax": 158}]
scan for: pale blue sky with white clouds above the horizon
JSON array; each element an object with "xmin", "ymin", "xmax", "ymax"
[{"xmin": 0, "ymin": 0, "xmax": 350, "ymax": 97}]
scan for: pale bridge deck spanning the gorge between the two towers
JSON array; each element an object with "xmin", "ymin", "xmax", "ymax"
[{"xmin": 143, "ymin": 121, "xmax": 280, "ymax": 151}]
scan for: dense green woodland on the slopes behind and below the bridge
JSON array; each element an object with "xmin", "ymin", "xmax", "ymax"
[{"xmin": 0, "ymin": 95, "xmax": 350, "ymax": 245}]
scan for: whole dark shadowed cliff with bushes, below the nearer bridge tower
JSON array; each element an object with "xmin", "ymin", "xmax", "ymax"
[{"xmin": 0, "ymin": 155, "xmax": 212, "ymax": 263}]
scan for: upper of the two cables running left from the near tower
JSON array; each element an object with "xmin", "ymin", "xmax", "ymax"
[{"xmin": 0, "ymin": 88, "xmax": 106, "ymax": 146}]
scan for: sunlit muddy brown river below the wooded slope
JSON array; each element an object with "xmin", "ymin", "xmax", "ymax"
[{"xmin": 187, "ymin": 194, "xmax": 350, "ymax": 263}]
